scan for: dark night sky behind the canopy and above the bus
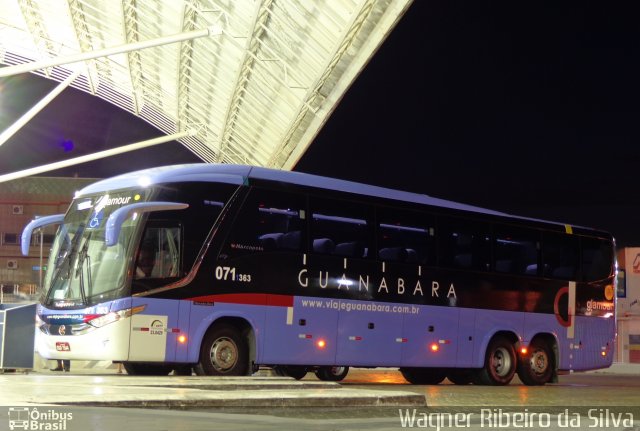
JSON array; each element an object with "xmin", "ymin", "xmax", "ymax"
[{"xmin": 0, "ymin": 0, "xmax": 640, "ymax": 246}]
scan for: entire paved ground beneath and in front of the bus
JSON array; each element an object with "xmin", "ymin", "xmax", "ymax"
[{"xmin": 0, "ymin": 364, "xmax": 640, "ymax": 431}]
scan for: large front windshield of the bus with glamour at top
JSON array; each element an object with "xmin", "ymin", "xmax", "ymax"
[{"xmin": 42, "ymin": 191, "xmax": 144, "ymax": 309}]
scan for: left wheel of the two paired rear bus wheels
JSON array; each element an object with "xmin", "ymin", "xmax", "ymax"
[{"xmin": 473, "ymin": 336, "xmax": 517, "ymax": 386}]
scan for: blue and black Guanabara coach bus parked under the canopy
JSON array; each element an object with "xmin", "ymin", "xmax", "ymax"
[{"xmin": 22, "ymin": 164, "xmax": 617, "ymax": 385}]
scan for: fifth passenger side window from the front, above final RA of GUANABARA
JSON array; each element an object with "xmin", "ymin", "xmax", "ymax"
[{"xmin": 494, "ymin": 226, "xmax": 539, "ymax": 275}]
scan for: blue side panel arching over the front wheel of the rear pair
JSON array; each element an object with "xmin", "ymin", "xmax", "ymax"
[{"xmin": 471, "ymin": 309, "xmax": 526, "ymax": 368}]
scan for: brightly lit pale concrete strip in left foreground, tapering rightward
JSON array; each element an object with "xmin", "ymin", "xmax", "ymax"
[{"xmin": 0, "ymin": 372, "xmax": 425, "ymax": 408}]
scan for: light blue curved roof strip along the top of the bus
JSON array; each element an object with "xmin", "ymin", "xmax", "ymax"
[{"xmin": 76, "ymin": 163, "xmax": 604, "ymax": 235}]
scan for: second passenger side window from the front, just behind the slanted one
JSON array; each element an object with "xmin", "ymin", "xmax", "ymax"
[{"xmin": 311, "ymin": 199, "xmax": 373, "ymax": 258}]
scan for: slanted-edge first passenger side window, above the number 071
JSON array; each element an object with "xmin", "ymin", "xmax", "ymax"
[{"xmin": 225, "ymin": 188, "xmax": 305, "ymax": 257}]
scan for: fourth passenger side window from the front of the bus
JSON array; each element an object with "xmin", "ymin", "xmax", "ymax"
[{"xmin": 437, "ymin": 219, "xmax": 491, "ymax": 271}]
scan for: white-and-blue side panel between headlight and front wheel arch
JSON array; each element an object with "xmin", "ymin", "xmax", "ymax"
[{"xmin": 129, "ymin": 297, "xmax": 179, "ymax": 362}]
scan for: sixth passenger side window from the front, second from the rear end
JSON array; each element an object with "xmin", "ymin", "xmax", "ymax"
[{"xmin": 542, "ymin": 232, "xmax": 580, "ymax": 280}]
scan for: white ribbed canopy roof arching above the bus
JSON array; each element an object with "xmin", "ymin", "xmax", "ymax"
[{"xmin": 0, "ymin": 0, "xmax": 412, "ymax": 176}]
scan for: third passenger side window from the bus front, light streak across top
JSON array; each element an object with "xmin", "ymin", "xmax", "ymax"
[{"xmin": 377, "ymin": 208, "xmax": 435, "ymax": 264}]
